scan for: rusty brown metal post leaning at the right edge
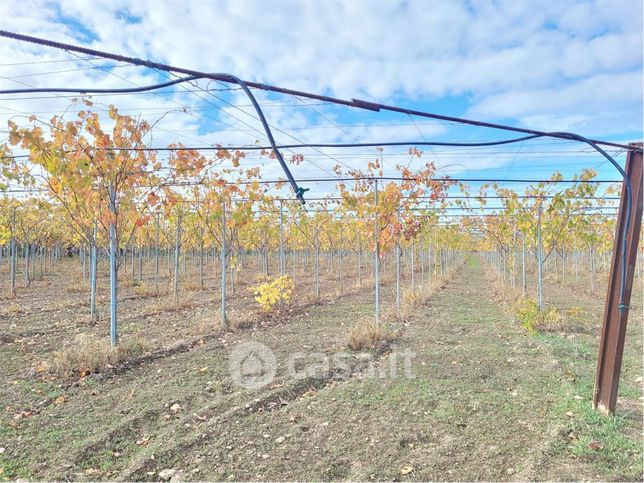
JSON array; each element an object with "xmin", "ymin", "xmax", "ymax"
[{"xmin": 593, "ymin": 143, "xmax": 644, "ymax": 414}]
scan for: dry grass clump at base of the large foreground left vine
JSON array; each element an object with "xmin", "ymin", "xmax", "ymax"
[{"xmin": 45, "ymin": 334, "xmax": 148, "ymax": 377}]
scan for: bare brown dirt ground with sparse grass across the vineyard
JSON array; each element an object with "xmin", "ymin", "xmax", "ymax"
[{"xmin": 0, "ymin": 257, "xmax": 644, "ymax": 480}]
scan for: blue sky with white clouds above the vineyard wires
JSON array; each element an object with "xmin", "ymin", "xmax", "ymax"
[{"xmin": 0, "ymin": 0, "xmax": 643, "ymax": 200}]
